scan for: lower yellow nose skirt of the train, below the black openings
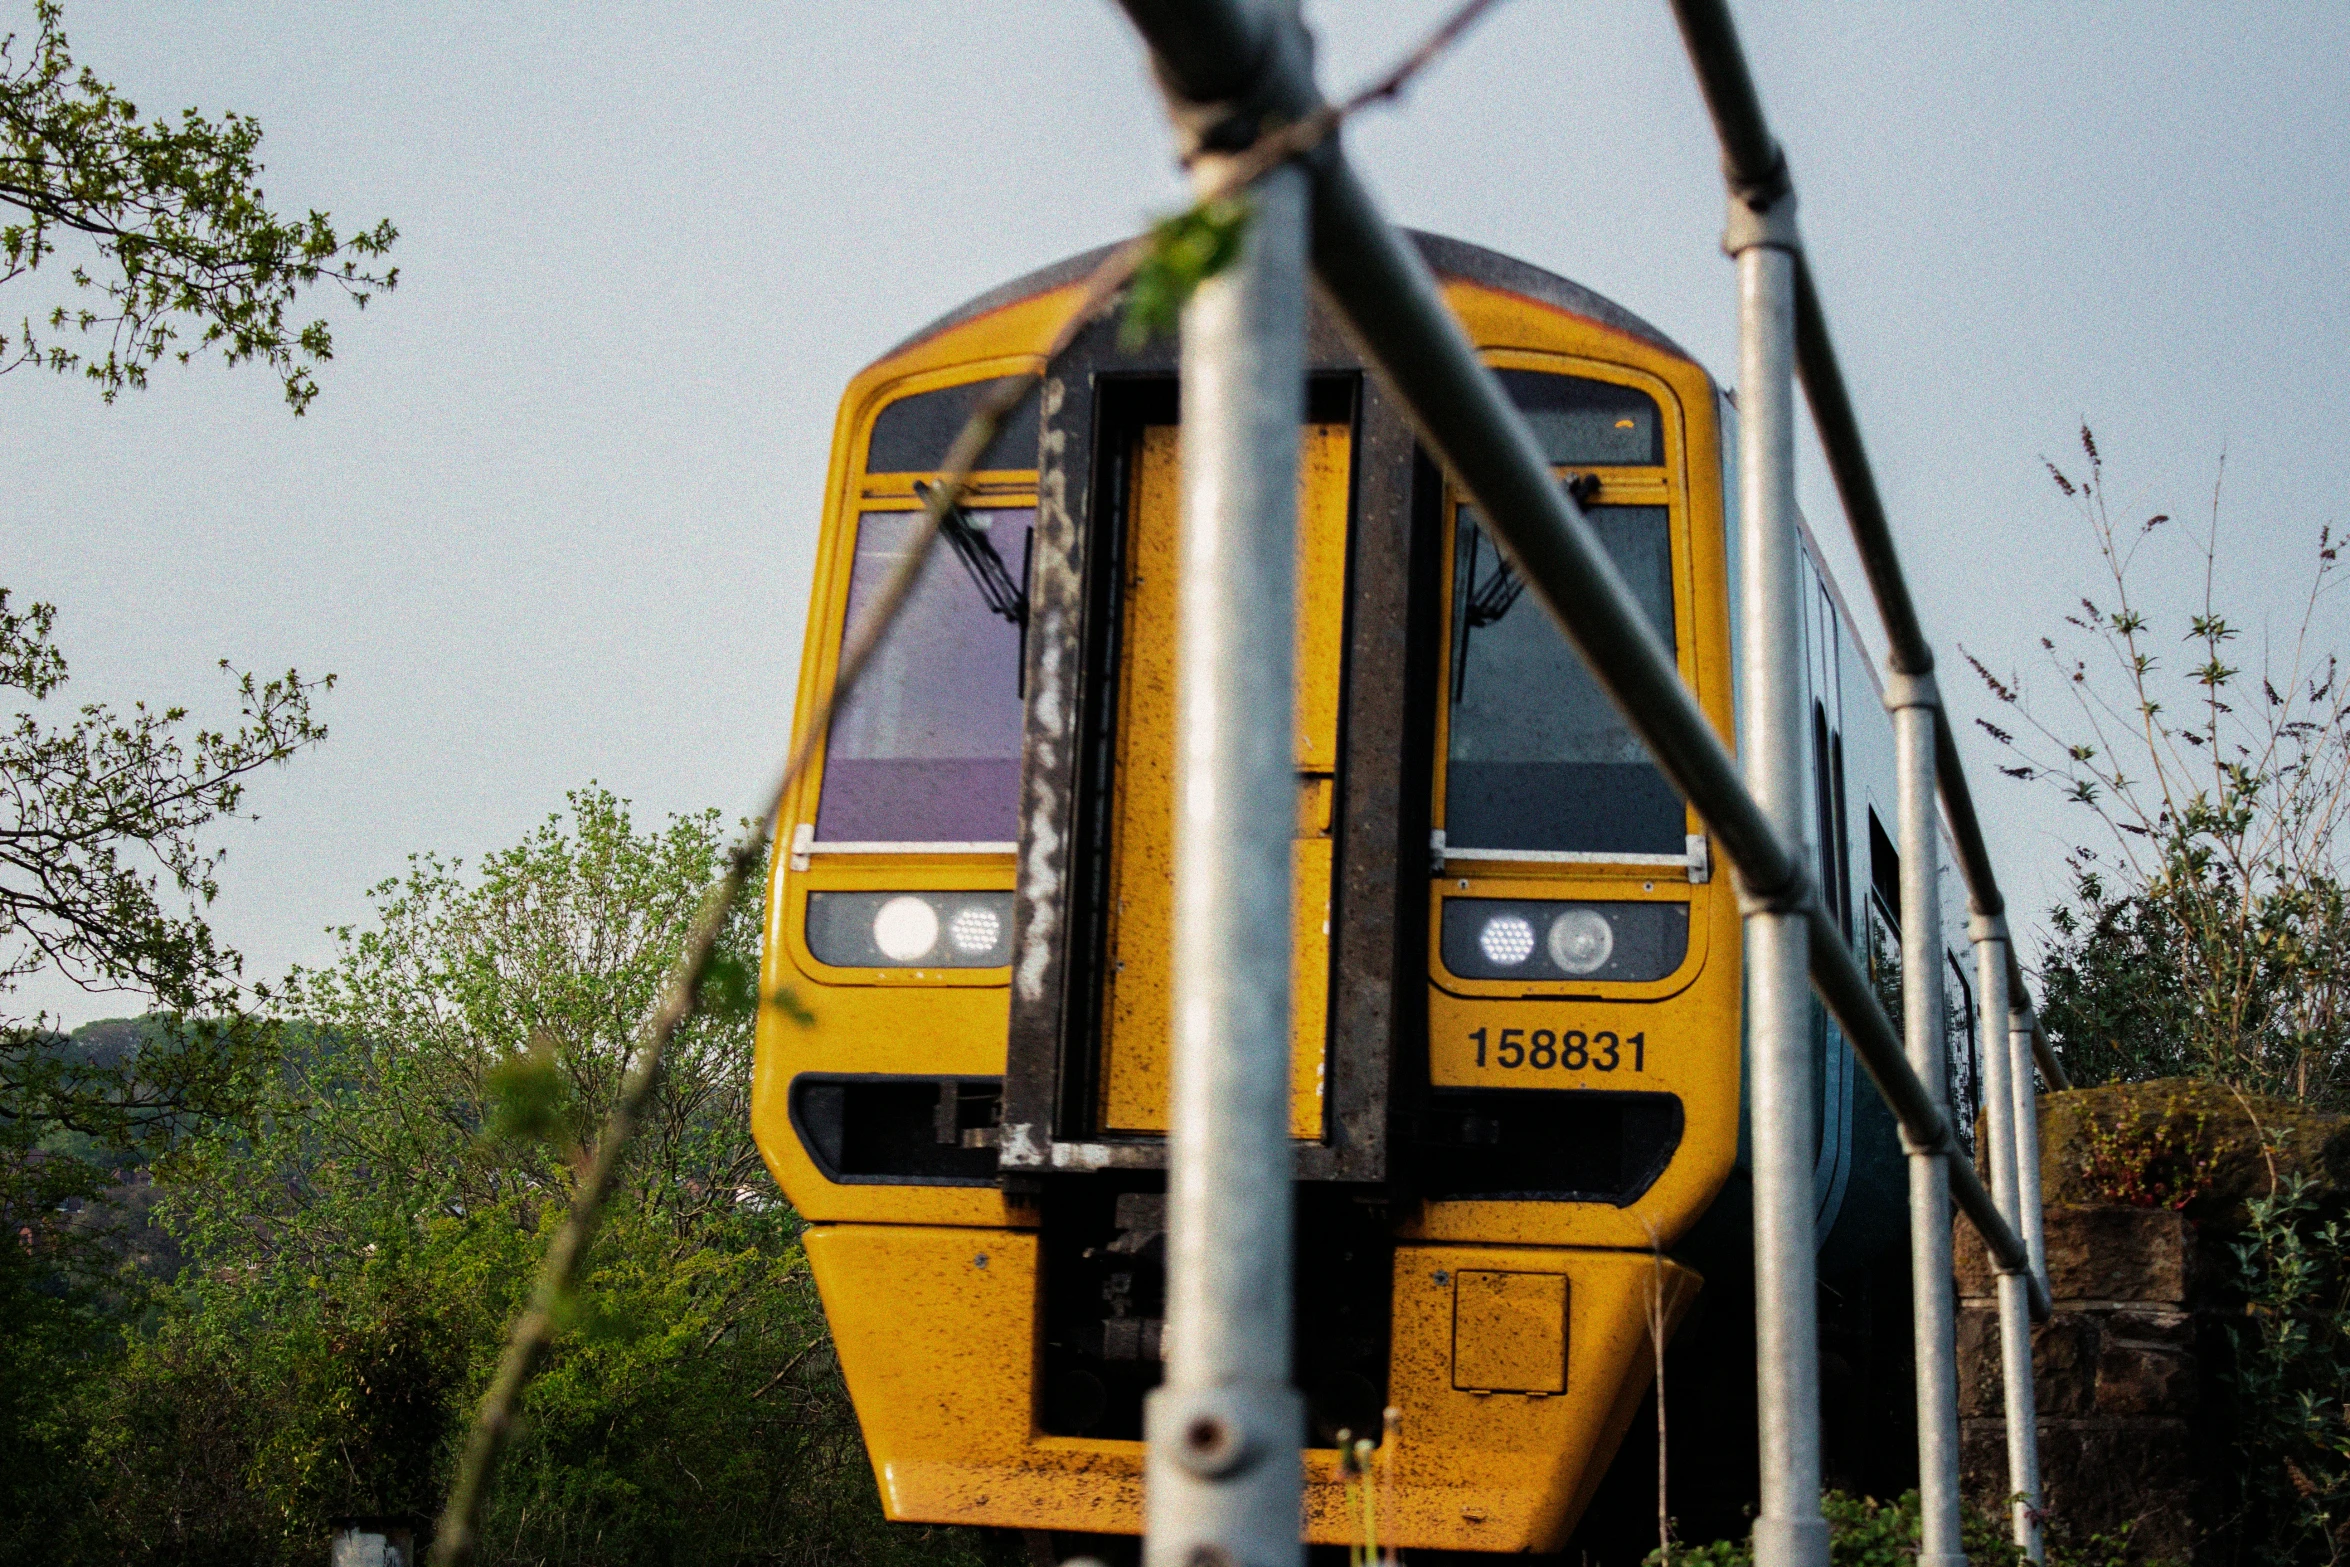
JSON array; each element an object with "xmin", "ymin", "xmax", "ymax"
[{"xmin": 806, "ymin": 1224, "xmax": 1701, "ymax": 1551}]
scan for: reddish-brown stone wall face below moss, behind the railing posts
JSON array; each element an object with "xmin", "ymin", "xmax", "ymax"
[{"xmin": 1958, "ymin": 1203, "xmax": 2214, "ymax": 1562}]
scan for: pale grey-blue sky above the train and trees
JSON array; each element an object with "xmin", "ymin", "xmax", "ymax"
[{"xmin": 13, "ymin": 0, "xmax": 2350, "ymax": 1020}]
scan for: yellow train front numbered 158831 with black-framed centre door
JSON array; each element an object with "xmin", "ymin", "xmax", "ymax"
[{"xmin": 752, "ymin": 235, "xmax": 1917, "ymax": 1551}]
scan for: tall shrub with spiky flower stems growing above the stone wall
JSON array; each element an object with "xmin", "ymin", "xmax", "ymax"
[{"xmin": 1974, "ymin": 428, "xmax": 2350, "ymax": 1107}]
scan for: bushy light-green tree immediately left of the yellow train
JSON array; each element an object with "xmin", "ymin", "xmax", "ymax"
[{"xmin": 39, "ymin": 787, "xmax": 975, "ymax": 1567}]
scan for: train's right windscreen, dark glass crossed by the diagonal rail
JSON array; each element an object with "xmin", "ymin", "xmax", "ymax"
[{"xmin": 1445, "ymin": 502, "xmax": 1687, "ymax": 855}]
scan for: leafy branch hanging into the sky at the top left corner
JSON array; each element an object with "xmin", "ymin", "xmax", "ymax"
[{"xmin": 0, "ymin": 0, "xmax": 400, "ymax": 413}]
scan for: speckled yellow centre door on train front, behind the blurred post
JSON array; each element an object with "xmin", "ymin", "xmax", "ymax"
[{"xmin": 1102, "ymin": 425, "xmax": 1351, "ymax": 1139}]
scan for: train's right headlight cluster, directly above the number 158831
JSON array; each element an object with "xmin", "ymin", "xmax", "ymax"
[{"xmin": 1436, "ymin": 897, "xmax": 1690, "ymax": 984}]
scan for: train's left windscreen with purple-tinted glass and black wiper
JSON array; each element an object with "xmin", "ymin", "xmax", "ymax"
[{"xmin": 815, "ymin": 507, "xmax": 1036, "ymax": 843}]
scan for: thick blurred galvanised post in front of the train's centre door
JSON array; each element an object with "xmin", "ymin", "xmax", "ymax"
[{"xmin": 1142, "ymin": 135, "xmax": 1311, "ymax": 1567}]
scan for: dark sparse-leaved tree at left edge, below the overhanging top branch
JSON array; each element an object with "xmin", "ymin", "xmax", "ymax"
[{"xmin": 0, "ymin": 590, "xmax": 331, "ymax": 1555}]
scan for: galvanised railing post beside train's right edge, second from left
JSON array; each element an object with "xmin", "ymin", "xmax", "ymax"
[{"xmin": 1723, "ymin": 202, "xmax": 1828, "ymax": 1567}]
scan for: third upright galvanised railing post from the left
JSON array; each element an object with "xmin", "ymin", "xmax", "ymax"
[{"xmin": 1885, "ymin": 674, "xmax": 1967, "ymax": 1567}]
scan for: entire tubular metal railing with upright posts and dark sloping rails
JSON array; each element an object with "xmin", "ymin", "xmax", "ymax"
[{"xmin": 1121, "ymin": 0, "xmax": 2063, "ymax": 1567}]
